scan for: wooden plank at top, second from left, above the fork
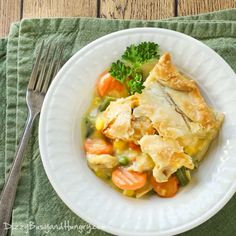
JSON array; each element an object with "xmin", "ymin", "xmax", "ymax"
[{"xmin": 23, "ymin": 0, "xmax": 97, "ymax": 18}]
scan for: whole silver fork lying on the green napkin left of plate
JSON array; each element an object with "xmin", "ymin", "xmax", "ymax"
[{"xmin": 0, "ymin": 41, "xmax": 62, "ymax": 236}]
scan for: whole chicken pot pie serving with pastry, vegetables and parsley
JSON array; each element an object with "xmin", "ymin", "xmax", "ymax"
[{"xmin": 84, "ymin": 42, "xmax": 224, "ymax": 198}]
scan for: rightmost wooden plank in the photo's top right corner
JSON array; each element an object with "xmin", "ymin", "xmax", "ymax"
[{"xmin": 177, "ymin": 0, "xmax": 236, "ymax": 16}]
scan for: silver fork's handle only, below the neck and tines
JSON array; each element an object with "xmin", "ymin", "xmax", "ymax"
[{"xmin": 0, "ymin": 113, "xmax": 37, "ymax": 236}]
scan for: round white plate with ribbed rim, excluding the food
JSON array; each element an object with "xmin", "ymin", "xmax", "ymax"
[{"xmin": 39, "ymin": 28, "xmax": 236, "ymax": 236}]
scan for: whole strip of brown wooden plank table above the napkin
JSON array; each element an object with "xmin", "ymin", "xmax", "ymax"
[{"xmin": 0, "ymin": 0, "xmax": 236, "ymax": 37}]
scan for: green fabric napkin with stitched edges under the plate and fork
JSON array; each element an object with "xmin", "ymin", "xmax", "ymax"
[{"xmin": 0, "ymin": 9, "xmax": 236, "ymax": 236}]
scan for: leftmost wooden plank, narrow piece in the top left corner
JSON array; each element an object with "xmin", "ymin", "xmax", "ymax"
[{"xmin": 0, "ymin": 0, "xmax": 21, "ymax": 37}]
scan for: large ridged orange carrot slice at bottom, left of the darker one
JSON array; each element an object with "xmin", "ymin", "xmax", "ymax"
[{"xmin": 112, "ymin": 167, "xmax": 147, "ymax": 190}]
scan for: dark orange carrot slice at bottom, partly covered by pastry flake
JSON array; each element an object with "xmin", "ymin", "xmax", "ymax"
[{"xmin": 151, "ymin": 176, "xmax": 179, "ymax": 197}]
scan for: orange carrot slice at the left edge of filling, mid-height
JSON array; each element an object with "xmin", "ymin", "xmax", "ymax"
[{"xmin": 84, "ymin": 138, "xmax": 113, "ymax": 155}]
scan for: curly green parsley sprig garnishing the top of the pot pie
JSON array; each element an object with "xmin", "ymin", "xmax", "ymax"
[{"xmin": 109, "ymin": 42, "xmax": 160, "ymax": 94}]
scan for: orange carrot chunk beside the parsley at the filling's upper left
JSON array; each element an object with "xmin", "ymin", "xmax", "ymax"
[{"xmin": 97, "ymin": 71, "xmax": 125, "ymax": 97}]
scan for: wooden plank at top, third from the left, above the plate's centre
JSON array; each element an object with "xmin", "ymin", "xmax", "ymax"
[{"xmin": 100, "ymin": 0, "xmax": 175, "ymax": 20}]
